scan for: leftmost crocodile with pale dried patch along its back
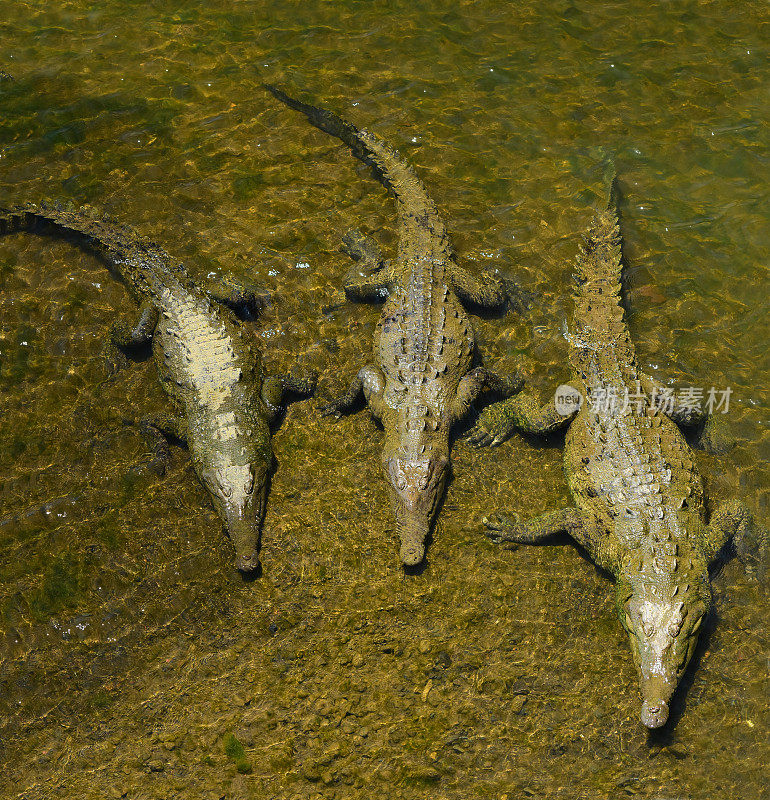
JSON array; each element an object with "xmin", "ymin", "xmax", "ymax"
[{"xmin": 0, "ymin": 206, "xmax": 315, "ymax": 574}]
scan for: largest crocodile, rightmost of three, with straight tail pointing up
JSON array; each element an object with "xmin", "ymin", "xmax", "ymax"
[{"xmin": 470, "ymin": 178, "xmax": 750, "ymax": 729}]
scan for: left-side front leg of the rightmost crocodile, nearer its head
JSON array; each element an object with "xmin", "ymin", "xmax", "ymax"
[{"xmin": 482, "ymin": 506, "xmax": 618, "ymax": 574}]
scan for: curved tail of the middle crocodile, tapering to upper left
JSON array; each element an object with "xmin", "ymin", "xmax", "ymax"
[{"xmin": 265, "ymin": 84, "xmax": 448, "ymax": 246}]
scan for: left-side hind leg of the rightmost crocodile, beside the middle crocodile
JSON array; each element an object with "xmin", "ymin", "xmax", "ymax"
[{"xmin": 468, "ymin": 392, "xmax": 577, "ymax": 447}]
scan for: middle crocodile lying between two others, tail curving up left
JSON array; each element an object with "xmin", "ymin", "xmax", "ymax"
[{"xmin": 265, "ymin": 86, "xmax": 523, "ymax": 567}]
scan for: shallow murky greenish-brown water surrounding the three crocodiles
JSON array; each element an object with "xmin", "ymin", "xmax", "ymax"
[{"xmin": 0, "ymin": 0, "xmax": 770, "ymax": 800}]
